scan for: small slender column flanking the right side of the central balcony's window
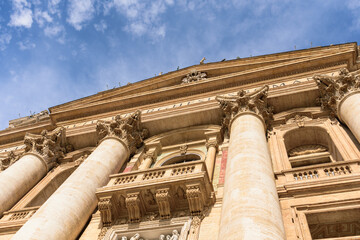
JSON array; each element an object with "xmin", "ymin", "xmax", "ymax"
[{"xmin": 205, "ymin": 132, "xmax": 220, "ymax": 181}]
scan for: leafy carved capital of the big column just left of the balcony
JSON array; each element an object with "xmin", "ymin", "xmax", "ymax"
[{"xmin": 96, "ymin": 111, "xmax": 148, "ymax": 154}]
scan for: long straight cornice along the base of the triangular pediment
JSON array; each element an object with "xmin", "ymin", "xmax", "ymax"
[{"xmin": 51, "ymin": 52, "xmax": 353, "ymax": 123}]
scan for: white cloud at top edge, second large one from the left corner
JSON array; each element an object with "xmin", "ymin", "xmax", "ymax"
[{"xmin": 67, "ymin": 0, "xmax": 95, "ymax": 31}]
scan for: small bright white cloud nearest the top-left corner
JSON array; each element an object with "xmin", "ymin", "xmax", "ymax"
[{"xmin": 8, "ymin": 0, "xmax": 33, "ymax": 28}]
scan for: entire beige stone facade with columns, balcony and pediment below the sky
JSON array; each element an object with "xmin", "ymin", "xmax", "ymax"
[{"xmin": 0, "ymin": 43, "xmax": 360, "ymax": 240}]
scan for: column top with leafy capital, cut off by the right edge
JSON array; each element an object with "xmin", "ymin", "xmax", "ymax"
[{"xmin": 314, "ymin": 68, "xmax": 360, "ymax": 142}]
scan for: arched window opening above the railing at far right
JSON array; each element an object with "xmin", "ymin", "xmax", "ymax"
[{"xmin": 284, "ymin": 127, "xmax": 343, "ymax": 167}]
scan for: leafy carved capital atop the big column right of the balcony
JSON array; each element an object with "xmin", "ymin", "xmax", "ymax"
[{"xmin": 215, "ymin": 85, "xmax": 273, "ymax": 128}]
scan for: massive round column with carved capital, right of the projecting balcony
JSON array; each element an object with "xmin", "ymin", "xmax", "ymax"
[{"xmin": 217, "ymin": 86, "xmax": 285, "ymax": 240}]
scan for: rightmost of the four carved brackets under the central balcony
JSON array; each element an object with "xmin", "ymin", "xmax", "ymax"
[{"xmin": 186, "ymin": 184, "xmax": 204, "ymax": 215}]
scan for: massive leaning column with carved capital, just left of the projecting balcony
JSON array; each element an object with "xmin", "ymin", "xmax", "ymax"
[{"xmin": 12, "ymin": 112, "xmax": 146, "ymax": 240}]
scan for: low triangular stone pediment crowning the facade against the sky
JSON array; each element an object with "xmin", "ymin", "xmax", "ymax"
[{"xmin": 50, "ymin": 43, "xmax": 357, "ymax": 123}]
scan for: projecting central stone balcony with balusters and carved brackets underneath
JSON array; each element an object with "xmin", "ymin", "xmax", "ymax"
[{"xmin": 96, "ymin": 161, "xmax": 215, "ymax": 226}]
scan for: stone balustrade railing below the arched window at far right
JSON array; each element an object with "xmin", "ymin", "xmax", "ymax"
[{"xmin": 275, "ymin": 160, "xmax": 360, "ymax": 185}]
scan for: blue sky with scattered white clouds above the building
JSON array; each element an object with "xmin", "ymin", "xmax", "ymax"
[{"xmin": 0, "ymin": 0, "xmax": 360, "ymax": 129}]
